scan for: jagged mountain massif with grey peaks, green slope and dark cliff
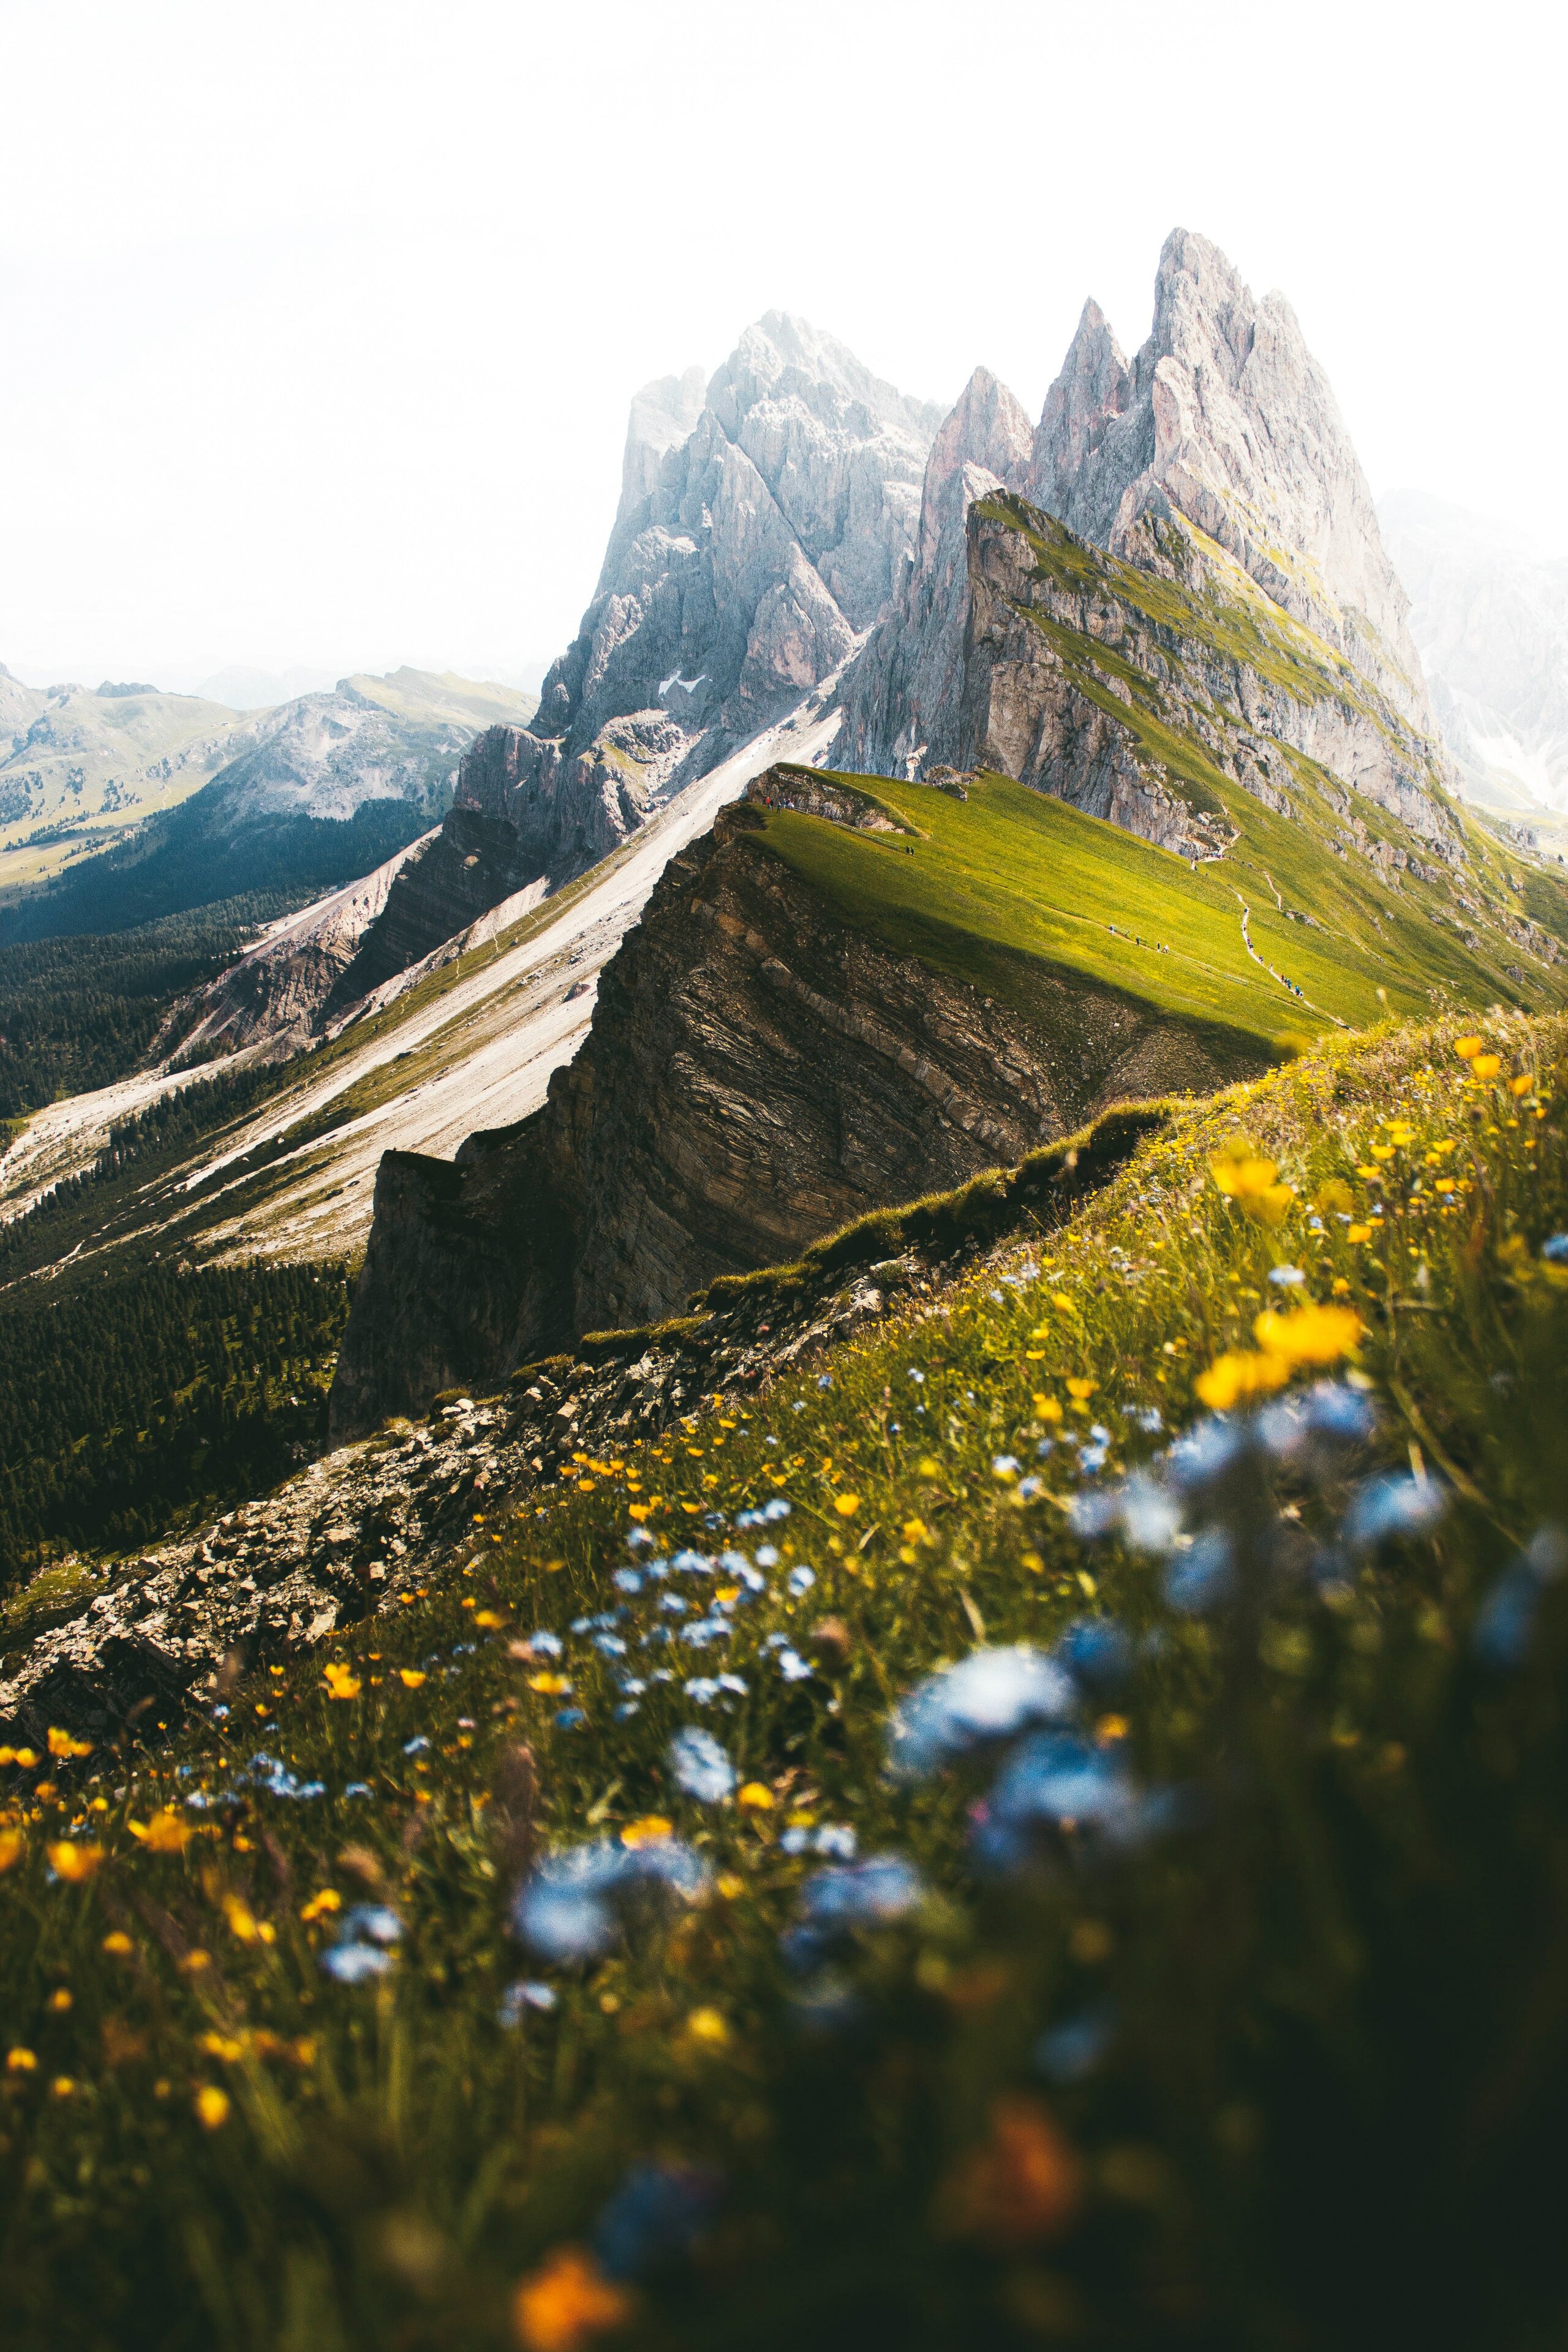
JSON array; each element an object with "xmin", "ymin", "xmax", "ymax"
[{"xmin": 0, "ymin": 230, "xmax": 1568, "ymax": 1430}]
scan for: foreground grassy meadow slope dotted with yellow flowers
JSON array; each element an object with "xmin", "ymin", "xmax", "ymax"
[{"xmin": 0, "ymin": 1016, "xmax": 1568, "ymax": 2352}]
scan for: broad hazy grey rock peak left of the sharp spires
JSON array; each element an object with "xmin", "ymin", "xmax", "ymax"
[{"xmin": 341, "ymin": 311, "xmax": 943, "ymax": 1000}]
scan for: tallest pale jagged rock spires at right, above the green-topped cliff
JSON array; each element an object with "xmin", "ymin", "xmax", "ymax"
[{"xmin": 1032, "ymin": 228, "xmax": 1430, "ymax": 727}]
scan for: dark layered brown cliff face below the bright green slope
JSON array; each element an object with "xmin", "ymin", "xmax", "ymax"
[{"xmin": 331, "ymin": 769, "xmax": 1260, "ymax": 1434}]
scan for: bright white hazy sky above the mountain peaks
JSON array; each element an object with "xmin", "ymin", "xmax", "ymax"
[{"xmin": 0, "ymin": 0, "xmax": 1568, "ymax": 684}]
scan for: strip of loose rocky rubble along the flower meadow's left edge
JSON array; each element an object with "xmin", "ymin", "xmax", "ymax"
[{"xmin": 0, "ymin": 1103, "xmax": 1166, "ymax": 1750}]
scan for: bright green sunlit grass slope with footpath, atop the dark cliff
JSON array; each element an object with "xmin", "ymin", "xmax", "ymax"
[{"xmin": 747, "ymin": 772, "xmax": 1568, "ymax": 1042}]
